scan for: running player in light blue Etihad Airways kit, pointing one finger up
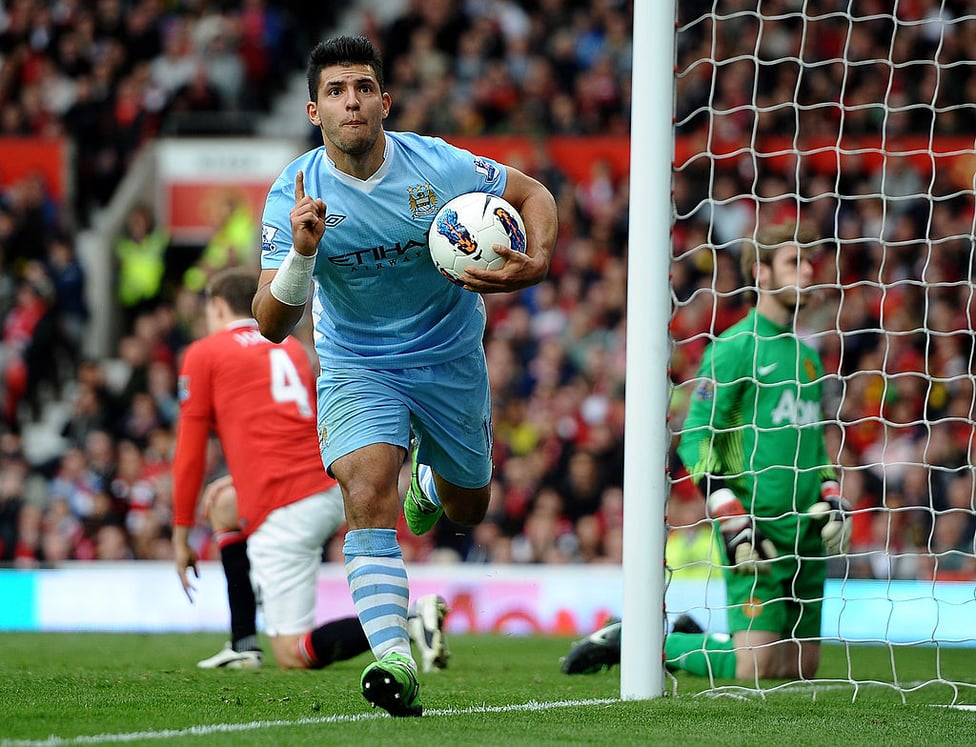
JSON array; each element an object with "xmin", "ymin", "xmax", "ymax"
[{"xmin": 253, "ymin": 37, "xmax": 557, "ymax": 716}]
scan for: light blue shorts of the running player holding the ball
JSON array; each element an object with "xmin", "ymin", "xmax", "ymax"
[{"xmin": 318, "ymin": 348, "xmax": 492, "ymax": 488}]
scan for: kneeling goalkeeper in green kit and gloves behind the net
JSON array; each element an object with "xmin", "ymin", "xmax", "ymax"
[{"xmin": 562, "ymin": 224, "xmax": 851, "ymax": 679}]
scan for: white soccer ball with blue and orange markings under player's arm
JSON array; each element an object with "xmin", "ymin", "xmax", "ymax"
[{"xmin": 427, "ymin": 192, "xmax": 525, "ymax": 285}]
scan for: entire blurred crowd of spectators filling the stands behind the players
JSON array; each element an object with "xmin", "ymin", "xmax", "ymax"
[{"xmin": 0, "ymin": 0, "xmax": 976, "ymax": 578}]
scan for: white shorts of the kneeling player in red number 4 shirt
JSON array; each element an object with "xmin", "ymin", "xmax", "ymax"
[{"xmin": 247, "ymin": 485, "xmax": 346, "ymax": 636}]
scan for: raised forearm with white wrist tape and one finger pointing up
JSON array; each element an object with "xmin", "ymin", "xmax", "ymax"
[{"xmin": 251, "ymin": 171, "xmax": 325, "ymax": 342}]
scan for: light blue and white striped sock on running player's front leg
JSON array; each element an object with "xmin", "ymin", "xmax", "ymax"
[{"xmin": 342, "ymin": 529, "xmax": 413, "ymax": 661}]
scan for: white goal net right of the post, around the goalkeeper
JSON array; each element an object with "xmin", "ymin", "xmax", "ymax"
[{"xmin": 666, "ymin": 0, "xmax": 976, "ymax": 703}]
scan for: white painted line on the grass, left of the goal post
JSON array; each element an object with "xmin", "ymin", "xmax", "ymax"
[{"xmin": 0, "ymin": 698, "xmax": 621, "ymax": 747}]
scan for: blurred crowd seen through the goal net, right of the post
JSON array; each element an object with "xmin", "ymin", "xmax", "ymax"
[{"xmin": 672, "ymin": 2, "xmax": 976, "ymax": 578}]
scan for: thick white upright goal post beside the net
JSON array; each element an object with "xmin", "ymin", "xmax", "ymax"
[{"xmin": 620, "ymin": 0, "xmax": 675, "ymax": 700}]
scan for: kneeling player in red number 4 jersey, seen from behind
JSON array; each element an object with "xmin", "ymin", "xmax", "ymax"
[{"xmin": 173, "ymin": 268, "xmax": 369, "ymax": 668}]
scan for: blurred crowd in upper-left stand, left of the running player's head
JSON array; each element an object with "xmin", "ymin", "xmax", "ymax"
[{"xmin": 0, "ymin": 0, "xmax": 334, "ymax": 221}]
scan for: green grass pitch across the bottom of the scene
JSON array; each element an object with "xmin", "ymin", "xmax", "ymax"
[{"xmin": 0, "ymin": 633, "xmax": 976, "ymax": 747}]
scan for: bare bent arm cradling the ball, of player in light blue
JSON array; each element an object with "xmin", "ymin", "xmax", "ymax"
[{"xmin": 461, "ymin": 166, "xmax": 559, "ymax": 293}]
